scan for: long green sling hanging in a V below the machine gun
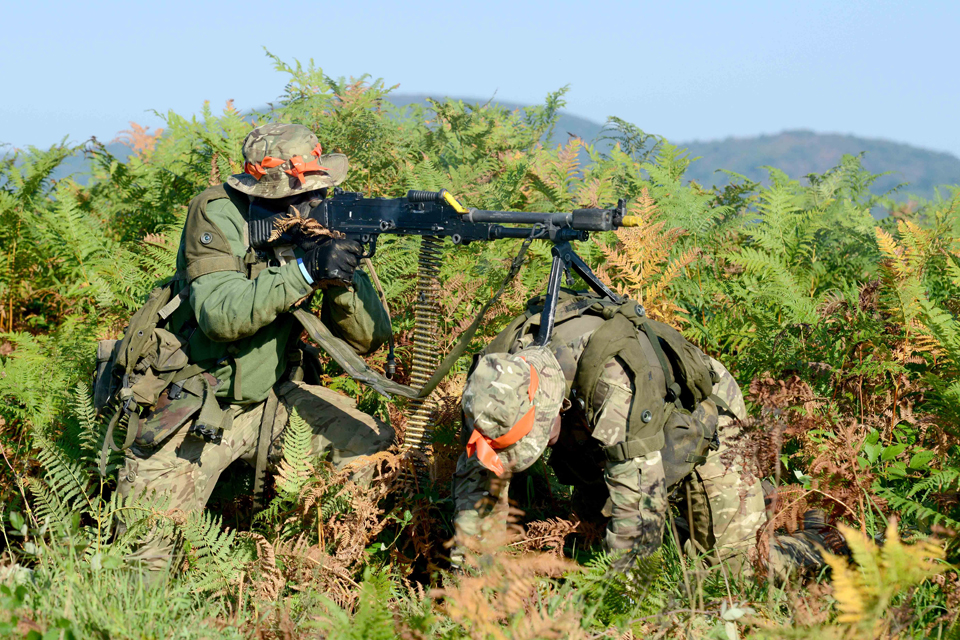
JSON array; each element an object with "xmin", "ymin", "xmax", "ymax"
[{"xmin": 293, "ymin": 238, "xmax": 532, "ymax": 399}]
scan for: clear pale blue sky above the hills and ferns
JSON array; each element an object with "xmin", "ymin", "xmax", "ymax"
[{"xmin": 0, "ymin": 0, "xmax": 960, "ymax": 156}]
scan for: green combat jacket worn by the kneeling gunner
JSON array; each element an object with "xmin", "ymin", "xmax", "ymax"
[{"xmin": 170, "ymin": 185, "xmax": 390, "ymax": 404}]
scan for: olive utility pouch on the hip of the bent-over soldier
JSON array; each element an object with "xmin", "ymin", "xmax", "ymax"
[{"xmin": 660, "ymin": 399, "xmax": 719, "ymax": 487}]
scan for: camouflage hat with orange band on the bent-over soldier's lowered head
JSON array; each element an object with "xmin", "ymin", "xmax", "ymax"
[{"xmin": 463, "ymin": 347, "xmax": 566, "ymax": 476}]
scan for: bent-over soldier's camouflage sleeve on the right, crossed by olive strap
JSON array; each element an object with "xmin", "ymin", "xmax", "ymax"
[{"xmin": 593, "ymin": 361, "xmax": 667, "ymax": 557}]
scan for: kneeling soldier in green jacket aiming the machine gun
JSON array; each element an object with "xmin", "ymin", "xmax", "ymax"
[{"xmin": 95, "ymin": 124, "xmax": 394, "ymax": 569}]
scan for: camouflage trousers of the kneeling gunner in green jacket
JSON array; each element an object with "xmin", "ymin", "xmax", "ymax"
[{"xmin": 117, "ymin": 382, "xmax": 394, "ymax": 570}]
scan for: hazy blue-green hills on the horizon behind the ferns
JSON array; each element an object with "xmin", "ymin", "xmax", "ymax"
[{"xmin": 22, "ymin": 94, "xmax": 960, "ymax": 200}]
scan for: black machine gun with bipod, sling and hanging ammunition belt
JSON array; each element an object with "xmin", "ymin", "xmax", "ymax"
[{"xmin": 260, "ymin": 189, "xmax": 638, "ymax": 458}]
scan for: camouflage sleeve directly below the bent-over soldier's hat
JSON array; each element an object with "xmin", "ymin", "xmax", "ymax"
[{"xmin": 450, "ymin": 453, "xmax": 509, "ymax": 567}]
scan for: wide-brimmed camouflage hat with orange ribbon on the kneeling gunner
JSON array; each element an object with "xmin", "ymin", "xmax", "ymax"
[{"xmin": 227, "ymin": 124, "xmax": 349, "ymax": 198}]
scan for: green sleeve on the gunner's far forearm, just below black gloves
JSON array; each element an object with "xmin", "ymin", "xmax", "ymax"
[{"xmin": 320, "ymin": 269, "xmax": 393, "ymax": 355}]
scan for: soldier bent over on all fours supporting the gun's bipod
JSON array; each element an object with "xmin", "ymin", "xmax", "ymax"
[{"xmin": 452, "ymin": 295, "xmax": 843, "ymax": 579}]
